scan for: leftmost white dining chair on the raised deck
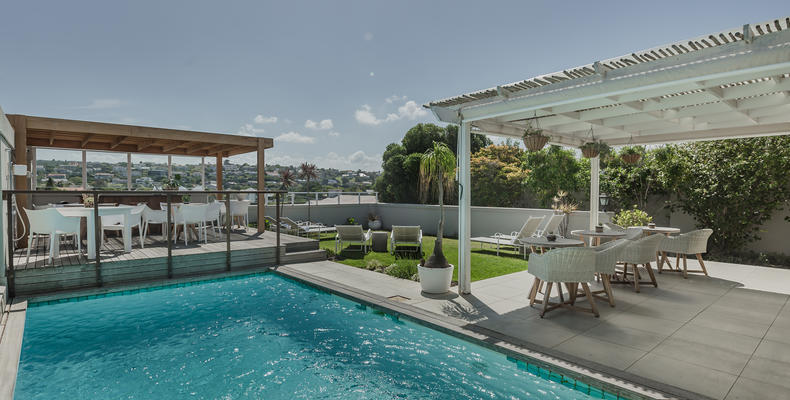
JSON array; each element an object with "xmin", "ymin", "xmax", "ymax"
[{"xmin": 25, "ymin": 208, "xmax": 82, "ymax": 264}]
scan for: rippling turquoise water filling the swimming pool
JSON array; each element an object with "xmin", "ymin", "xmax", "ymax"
[{"xmin": 15, "ymin": 274, "xmax": 616, "ymax": 399}]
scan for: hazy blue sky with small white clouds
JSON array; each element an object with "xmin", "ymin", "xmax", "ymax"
[{"xmin": 0, "ymin": 0, "xmax": 790, "ymax": 170}]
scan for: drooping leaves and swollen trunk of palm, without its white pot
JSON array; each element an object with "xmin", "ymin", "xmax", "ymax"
[{"xmin": 420, "ymin": 142, "xmax": 455, "ymax": 268}]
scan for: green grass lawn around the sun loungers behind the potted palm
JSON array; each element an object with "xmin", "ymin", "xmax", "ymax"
[{"xmin": 321, "ymin": 235, "xmax": 527, "ymax": 281}]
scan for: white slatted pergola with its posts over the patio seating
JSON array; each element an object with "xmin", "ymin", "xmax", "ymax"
[{"xmin": 425, "ymin": 17, "xmax": 790, "ymax": 294}]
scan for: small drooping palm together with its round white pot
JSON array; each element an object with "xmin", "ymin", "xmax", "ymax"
[{"xmin": 417, "ymin": 142, "xmax": 455, "ymax": 294}]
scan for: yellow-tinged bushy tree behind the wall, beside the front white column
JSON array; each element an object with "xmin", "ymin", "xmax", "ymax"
[{"xmin": 471, "ymin": 144, "xmax": 529, "ymax": 207}]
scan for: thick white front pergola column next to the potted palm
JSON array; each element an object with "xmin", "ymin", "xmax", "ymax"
[{"xmin": 458, "ymin": 121, "xmax": 472, "ymax": 294}]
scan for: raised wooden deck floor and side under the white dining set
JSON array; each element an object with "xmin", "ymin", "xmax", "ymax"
[{"xmin": 14, "ymin": 229, "xmax": 325, "ymax": 295}]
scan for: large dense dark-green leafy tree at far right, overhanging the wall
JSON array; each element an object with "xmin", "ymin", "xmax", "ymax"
[{"xmin": 656, "ymin": 136, "xmax": 790, "ymax": 254}]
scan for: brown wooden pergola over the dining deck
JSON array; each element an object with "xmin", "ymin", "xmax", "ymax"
[{"xmin": 7, "ymin": 114, "xmax": 274, "ymax": 231}]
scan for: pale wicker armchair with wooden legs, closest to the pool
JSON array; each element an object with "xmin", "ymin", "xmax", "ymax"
[{"xmin": 529, "ymin": 247, "xmax": 598, "ymax": 318}]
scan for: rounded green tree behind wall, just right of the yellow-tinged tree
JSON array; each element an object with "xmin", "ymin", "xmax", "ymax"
[{"xmin": 522, "ymin": 145, "xmax": 590, "ymax": 208}]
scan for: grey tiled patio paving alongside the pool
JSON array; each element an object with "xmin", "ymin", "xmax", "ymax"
[{"xmin": 285, "ymin": 261, "xmax": 790, "ymax": 399}]
